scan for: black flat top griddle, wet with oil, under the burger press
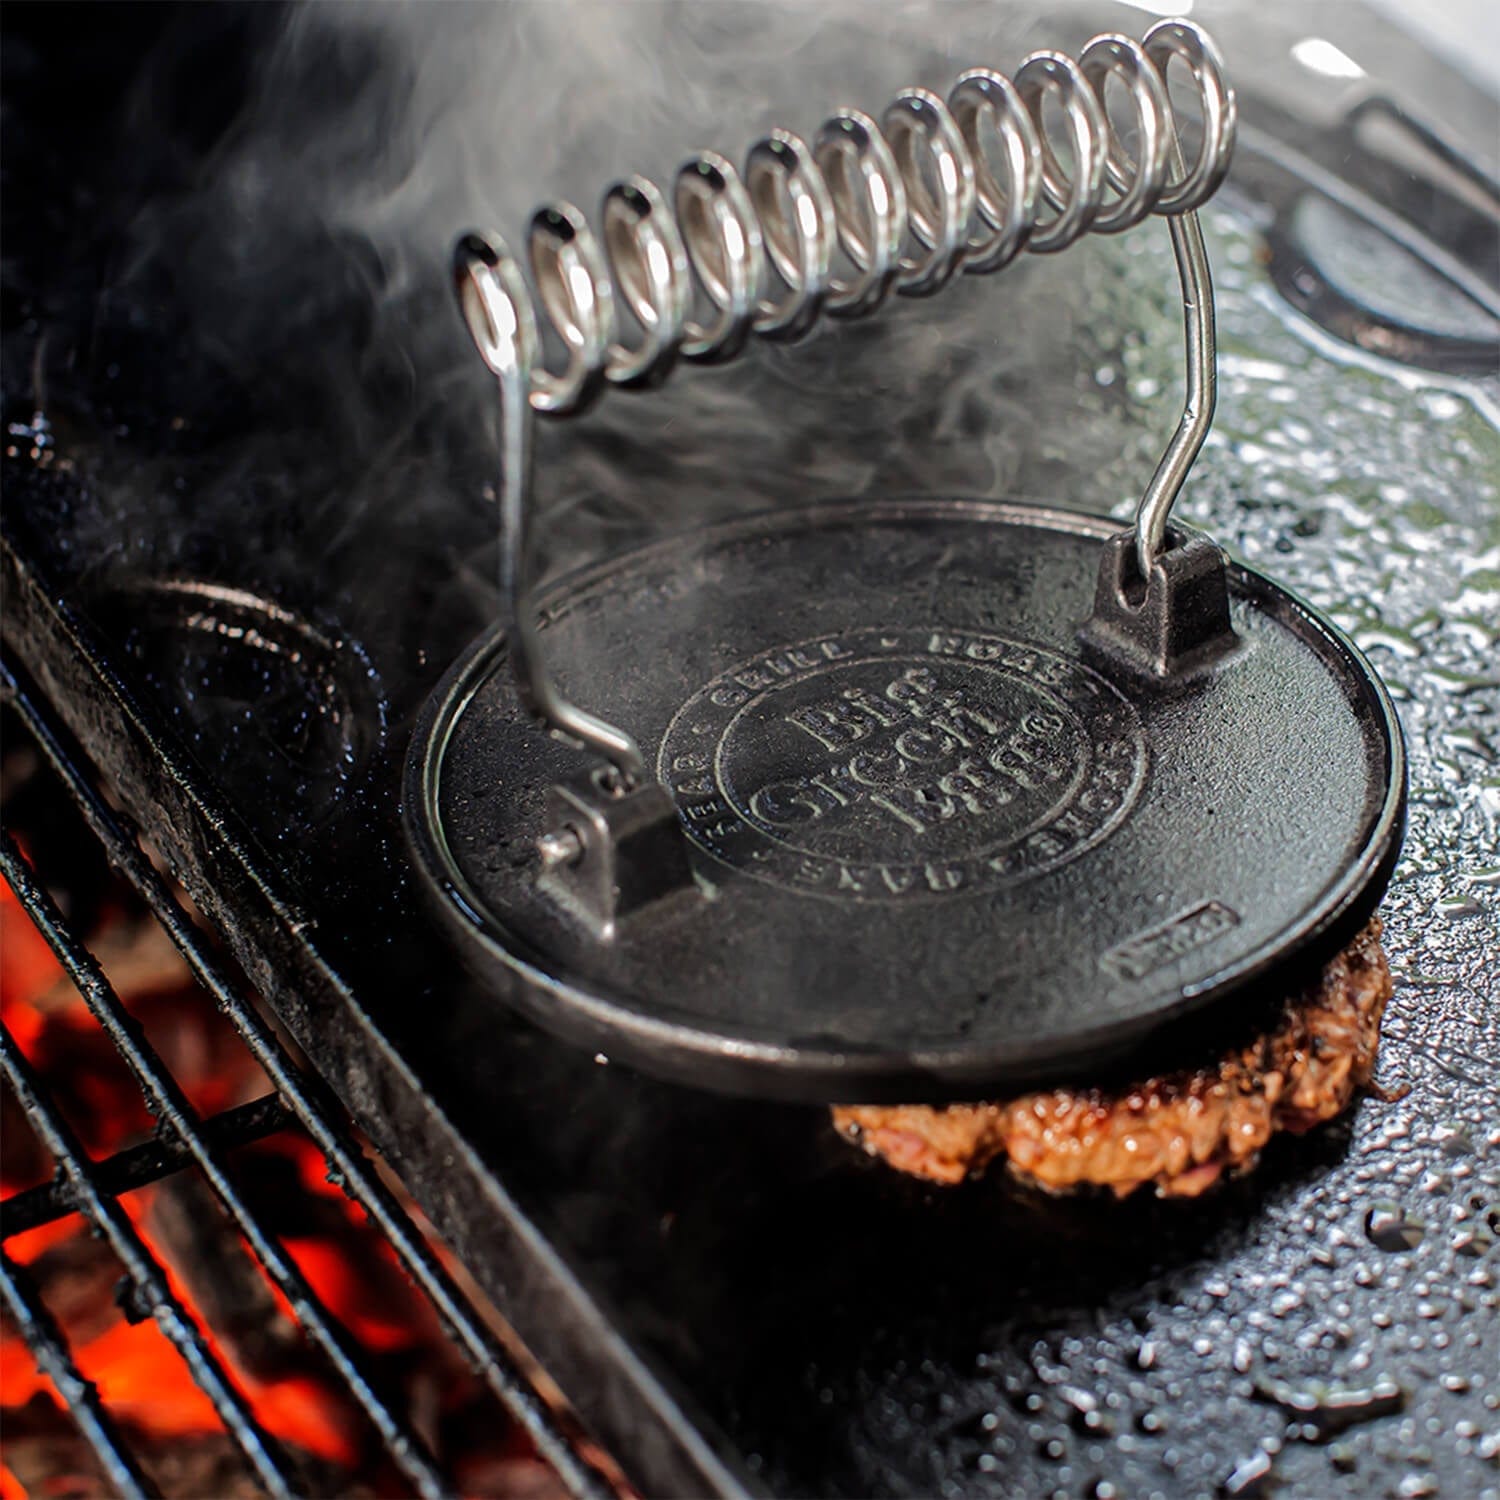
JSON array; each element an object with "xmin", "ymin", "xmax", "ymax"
[{"xmin": 3, "ymin": 5, "xmax": 1500, "ymax": 1497}]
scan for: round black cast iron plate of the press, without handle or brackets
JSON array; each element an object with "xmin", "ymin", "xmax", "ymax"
[{"xmin": 407, "ymin": 501, "xmax": 1406, "ymax": 1101}]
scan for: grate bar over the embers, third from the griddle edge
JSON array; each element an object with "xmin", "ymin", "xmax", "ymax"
[{"xmin": 0, "ymin": 1014, "xmax": 297, "ymax": 1500}]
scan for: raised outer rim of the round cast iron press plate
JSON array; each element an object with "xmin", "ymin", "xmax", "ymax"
[{"xmin": 402, "ymin": 497, "xmax": 1407, "ymax": 1104}]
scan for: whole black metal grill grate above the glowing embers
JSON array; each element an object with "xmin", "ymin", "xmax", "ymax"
[{"xmin": 0, "ymin": 663, "xmax": 617, "ymax": 1497}]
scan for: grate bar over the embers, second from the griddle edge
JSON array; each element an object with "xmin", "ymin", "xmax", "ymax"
[{"xmin": 0, "ymin": 831, "xmax": 450, "ymax": 1500}]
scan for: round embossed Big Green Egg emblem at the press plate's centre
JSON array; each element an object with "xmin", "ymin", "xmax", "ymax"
[{"xmin": 660, "ymin": 630, "xmax": 1148, "ymax": 900}]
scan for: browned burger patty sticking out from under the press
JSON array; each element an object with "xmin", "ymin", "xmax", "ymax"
[{"xmin": 834, "ymin": 918, "xmax": 1391, "ymax": 1197}]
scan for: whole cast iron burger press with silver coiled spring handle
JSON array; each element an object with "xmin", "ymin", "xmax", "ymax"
[{"xmin": 407, "ymin": 21, "xmax": 1406, "ymax": 1103}]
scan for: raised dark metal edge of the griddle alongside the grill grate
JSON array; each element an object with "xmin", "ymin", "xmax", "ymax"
[{"xmin": 0, "ymin": 536, "xmax": 767, "ymax": 1497}]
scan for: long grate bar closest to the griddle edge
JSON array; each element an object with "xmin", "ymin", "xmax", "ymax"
[{"xmin": 0, "ymin": 663, "xmax": 617, "ymax": 1500}]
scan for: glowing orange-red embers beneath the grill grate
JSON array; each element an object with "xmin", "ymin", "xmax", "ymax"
[{"xmin": 0, "ymin": 830, "xmax": 557, "ymax": 1500}]
